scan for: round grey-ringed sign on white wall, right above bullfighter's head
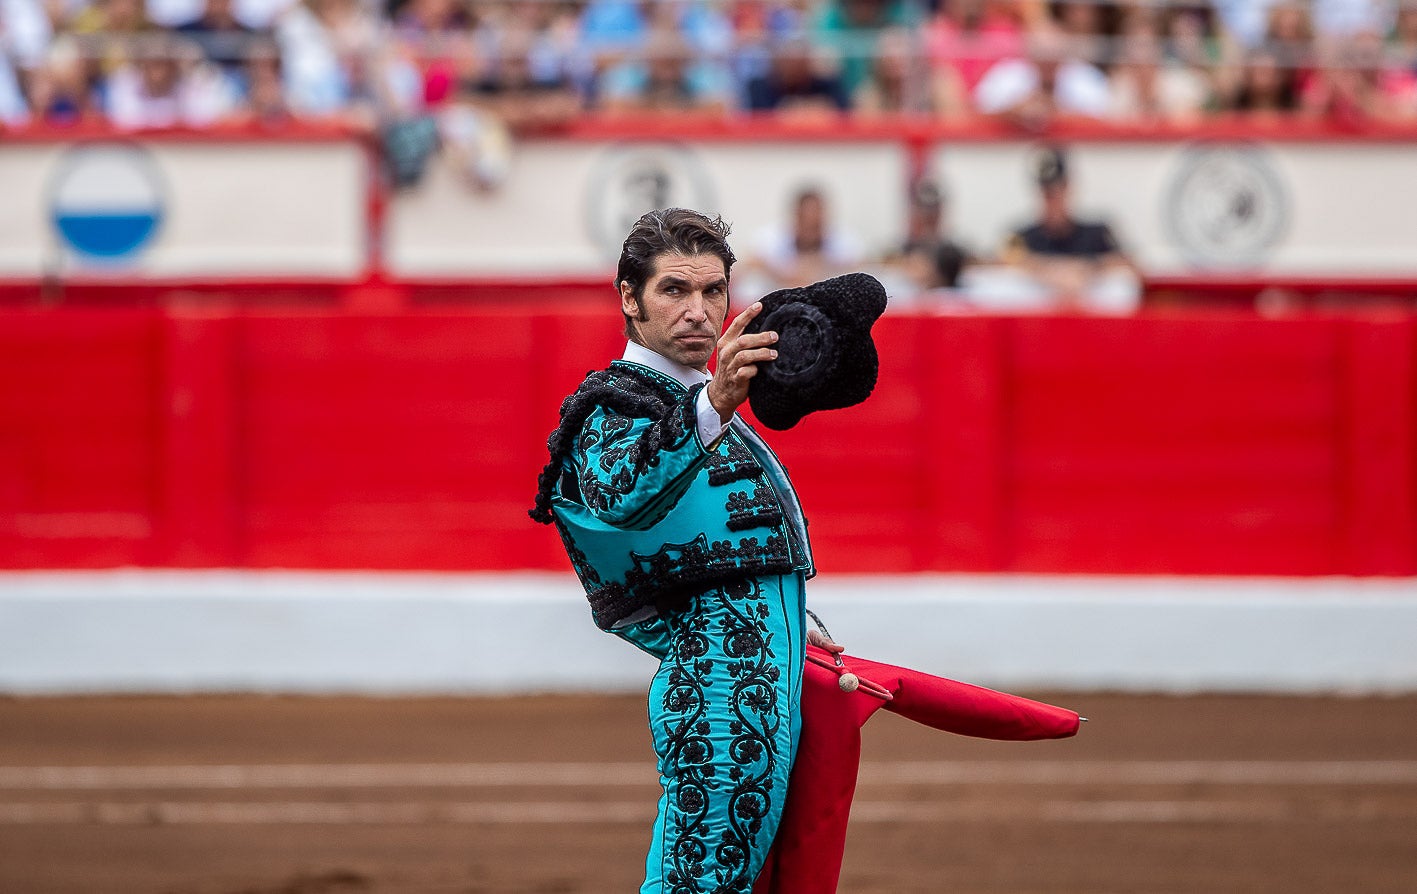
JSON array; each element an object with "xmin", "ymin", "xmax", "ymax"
[{"xmin": 587, "ymin": 143, "xmax": 716, "ymax": 261}]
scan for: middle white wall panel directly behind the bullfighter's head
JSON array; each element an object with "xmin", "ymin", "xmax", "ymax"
[{"xmin": 388, "ymin": 140, "xmax": 908, "ymax": 276}]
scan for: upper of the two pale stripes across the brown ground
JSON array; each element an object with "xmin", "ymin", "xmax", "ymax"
[{"xmin": 0, "ymin": 761, "xmax": 1417, "ymax": 791}]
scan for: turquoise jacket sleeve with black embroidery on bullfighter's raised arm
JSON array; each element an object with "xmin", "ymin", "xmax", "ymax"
[{"xmin": 568, "ymin": 388, "xmax": 710, "ymax": 528}]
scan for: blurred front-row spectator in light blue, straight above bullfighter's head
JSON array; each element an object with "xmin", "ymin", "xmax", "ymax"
[{"xmin": 597, "ymin": 31, "xmax": 735, "ymax": 113}]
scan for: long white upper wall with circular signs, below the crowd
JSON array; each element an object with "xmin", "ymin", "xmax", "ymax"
[{"xmin": 0, "ymin": 133, "xmax": 1417, "ymax": 279}]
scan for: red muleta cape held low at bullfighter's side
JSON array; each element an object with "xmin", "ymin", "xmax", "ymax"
[{"xmin": 752, "ymin": 646, "xmax": 1078, "ymax": 894}]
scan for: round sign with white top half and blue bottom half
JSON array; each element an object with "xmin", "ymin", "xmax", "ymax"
[{"xmin": 50, "ymin": 143, "xmax": 166, "ymax": 262}]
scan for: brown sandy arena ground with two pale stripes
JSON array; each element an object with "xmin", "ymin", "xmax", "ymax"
[{"xmin": 0, "ymin": 693, "xmax": 1417, "ymax": 894}]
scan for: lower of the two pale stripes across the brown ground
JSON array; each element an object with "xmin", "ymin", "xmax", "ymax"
[{"xmin": 0, "ymin": 799, "xmax": 1417, "ymax": 826}]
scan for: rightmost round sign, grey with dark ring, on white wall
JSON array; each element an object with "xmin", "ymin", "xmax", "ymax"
[{"xmin": 1166, "ymin": 146, "xmax": 1288, "ymax": 266}]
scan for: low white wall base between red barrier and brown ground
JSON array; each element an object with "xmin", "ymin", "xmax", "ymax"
[{"xmin": 0, "ymin": 571, "xmax": 1417, "ymax": 693}]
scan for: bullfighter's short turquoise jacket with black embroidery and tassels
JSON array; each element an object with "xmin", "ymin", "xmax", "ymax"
[{"xmin": 531, "ymin": 361, "xmax": 813, "ymax": 630}]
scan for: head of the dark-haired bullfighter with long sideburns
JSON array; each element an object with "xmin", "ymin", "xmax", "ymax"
[{"xmin": 615, "ymin": 208, "xmax": 737, "ymax": 370}]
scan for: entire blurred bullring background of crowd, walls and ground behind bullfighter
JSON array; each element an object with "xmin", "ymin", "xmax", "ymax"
[{"xmin": 0, "ymin": 0, "xmax": 1417, "ymax": 893}]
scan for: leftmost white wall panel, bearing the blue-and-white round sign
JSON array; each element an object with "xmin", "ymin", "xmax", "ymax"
[{"xmin": 0, "ymin": 140, "xmax": 368, "ymax": 278}]
